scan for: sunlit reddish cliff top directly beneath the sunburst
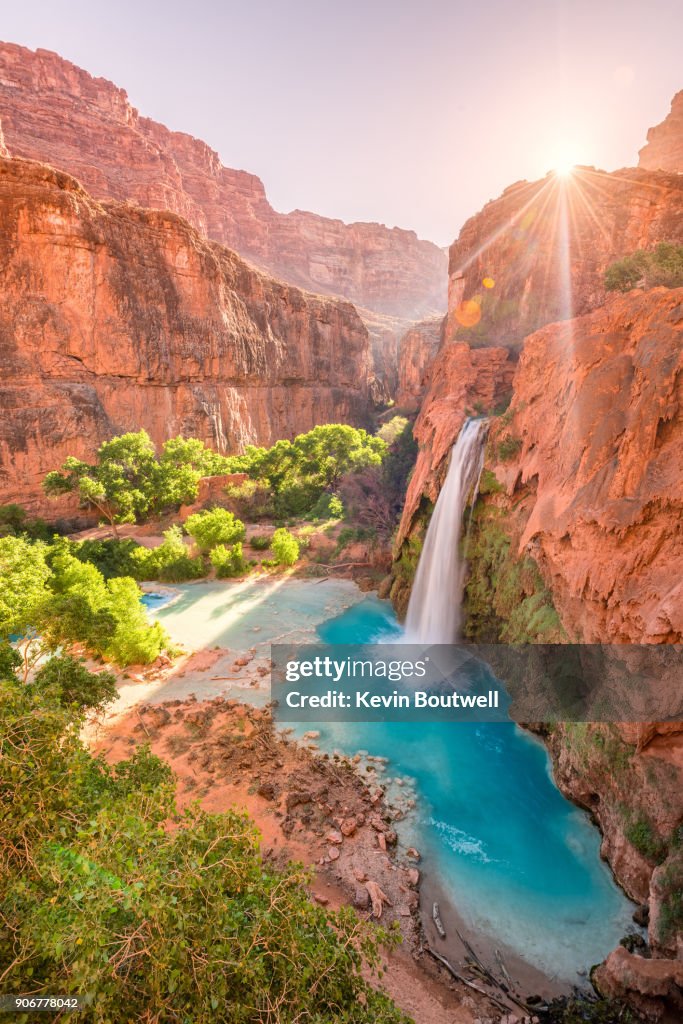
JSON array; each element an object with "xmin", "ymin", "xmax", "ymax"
[{"xmin": 446, "ymin": 168, "xmax": 683, "ymax": 346}]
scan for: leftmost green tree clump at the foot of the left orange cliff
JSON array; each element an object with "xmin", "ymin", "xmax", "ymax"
[{"xmin": 43, "ymin": 430, "xmax": 228, "ymax": 529}]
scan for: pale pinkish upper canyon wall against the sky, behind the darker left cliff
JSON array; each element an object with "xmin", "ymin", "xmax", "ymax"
[{"xmin": 0, "ymin": 43, "xmax": 446, "ymax": 319}]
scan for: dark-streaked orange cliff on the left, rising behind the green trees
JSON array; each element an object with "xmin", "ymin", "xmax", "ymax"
[{"xmin": 0, "ymin": 159, "xmax": 371, "ymax": 509}]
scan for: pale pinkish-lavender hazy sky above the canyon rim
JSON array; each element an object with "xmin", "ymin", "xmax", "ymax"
[{"xmin": 0, "ymin": 0, "xmax": 683, "ymax": 244}]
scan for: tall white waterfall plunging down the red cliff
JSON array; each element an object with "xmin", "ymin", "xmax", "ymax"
[{"xmin": 405, "ymin": 420, "xmax": 487, "ymax": 643}]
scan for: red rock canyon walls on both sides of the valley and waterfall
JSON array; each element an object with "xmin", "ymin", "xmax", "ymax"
[{"xmin": 0, "ymin": 43, "xmax": 683, "ymax": 1020}]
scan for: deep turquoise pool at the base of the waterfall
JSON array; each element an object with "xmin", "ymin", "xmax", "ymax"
[{"xmin": 315, "ymin": 598, "xmax": 634, "ymax": 982}]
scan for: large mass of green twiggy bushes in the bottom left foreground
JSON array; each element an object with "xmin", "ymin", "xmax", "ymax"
[{"xmin": 0, "ymin": 683, "xmax": 405, "ymax": 1024}]
